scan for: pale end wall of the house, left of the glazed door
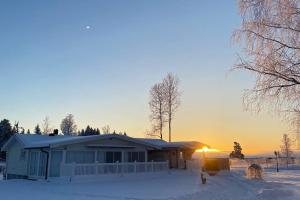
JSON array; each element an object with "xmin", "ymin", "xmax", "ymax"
[{"xmin": 6, "ymin": 141, "xmax": 28, "ymax": 179}]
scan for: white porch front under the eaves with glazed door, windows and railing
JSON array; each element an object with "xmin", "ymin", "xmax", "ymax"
[{"xmin": 28, "ymin": 149, "xmax": 169, "ymax": 179}]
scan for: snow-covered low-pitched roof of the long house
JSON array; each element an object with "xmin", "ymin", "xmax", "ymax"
[{"xmin": 1, "ymin": 134, "xmax": 207, "ymax": 151}]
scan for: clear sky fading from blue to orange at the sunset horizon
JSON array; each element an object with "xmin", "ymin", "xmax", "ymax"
[{"xmin": 0, "ymin": 0, "xmax": 289, "ymax": 153}]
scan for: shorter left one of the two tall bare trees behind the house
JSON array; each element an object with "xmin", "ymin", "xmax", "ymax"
[{"xmin": 148, "ymin": 83, "xmax": 166, "ymax": 140}]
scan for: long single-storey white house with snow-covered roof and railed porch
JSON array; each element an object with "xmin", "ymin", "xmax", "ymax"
[{"xmin": 1, "ymin": 134, "xmax": 204, "ymax": 179}]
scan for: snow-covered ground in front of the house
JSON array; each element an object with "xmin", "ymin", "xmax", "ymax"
[{"xmin": 0, "ymin": 169, "xmax": 300, "ymax": 200}]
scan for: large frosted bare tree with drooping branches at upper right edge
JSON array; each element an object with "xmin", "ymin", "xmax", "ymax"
[{"xmin": 233, "ymin": 0, "xmax": 300, "ymax": 111}]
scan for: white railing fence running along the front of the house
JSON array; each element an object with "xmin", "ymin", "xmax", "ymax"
[{"xmin": 60, "ymin": 161, "xmax": 169, "ymax": 176}]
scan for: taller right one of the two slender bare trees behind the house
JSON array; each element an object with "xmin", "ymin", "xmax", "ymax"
[{"xmin": 162, "ymin": 73, "xmax": 181, "ymax": 142}]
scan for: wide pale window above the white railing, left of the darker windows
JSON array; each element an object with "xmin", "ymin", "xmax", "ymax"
[{"xmin": 66, "ymin": 151, "xmax": 95, "ymax": 163}]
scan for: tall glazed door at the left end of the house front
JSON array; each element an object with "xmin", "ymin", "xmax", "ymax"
[{"xmin": 29, "ymin": 151, "xmax": 47, "ymax": 179}]
